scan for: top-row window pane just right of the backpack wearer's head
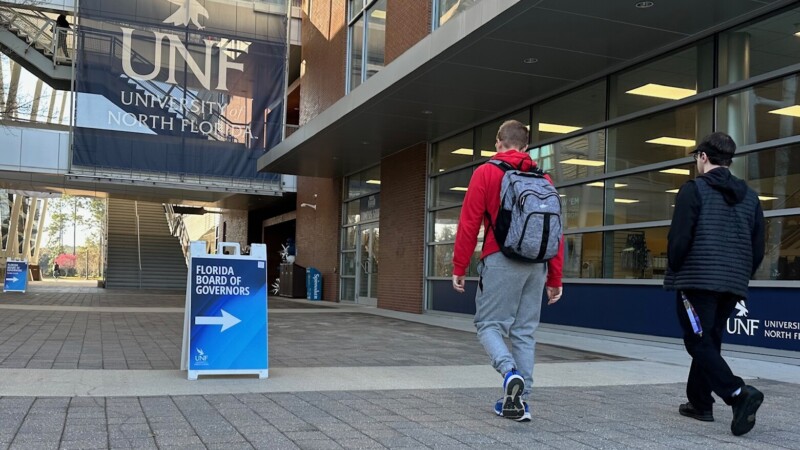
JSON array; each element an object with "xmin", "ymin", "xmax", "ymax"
[{"xmin": 531, "ymin": 80, "xmax": 606, "ymax": 143}]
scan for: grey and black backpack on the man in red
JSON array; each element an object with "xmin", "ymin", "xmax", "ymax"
[{"xmin": 486, "ymin": 159, "xmax": 562, "ymax": 262}]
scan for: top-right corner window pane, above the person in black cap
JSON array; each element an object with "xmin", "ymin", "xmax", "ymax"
[{"xmin": 719, "ymin": 8, "xmax": 800, "ymax": 86}]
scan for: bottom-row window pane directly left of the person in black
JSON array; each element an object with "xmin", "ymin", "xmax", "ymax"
[{"xmin": 603, "ymin": 227, "xmax": 669, "ymax": 279}]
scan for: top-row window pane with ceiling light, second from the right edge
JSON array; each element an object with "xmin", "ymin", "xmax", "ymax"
[{"xmin": 609, "ymin": 39, "xmax": 714, "ymax": 119}]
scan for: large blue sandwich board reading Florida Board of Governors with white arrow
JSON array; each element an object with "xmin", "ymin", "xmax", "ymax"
[{"xmin": 181, "ymin": 241, "xmax": 269, "ymax": 380}]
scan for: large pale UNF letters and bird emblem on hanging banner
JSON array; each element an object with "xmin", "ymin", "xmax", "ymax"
[{"xmin": 120, "ymin": 0, "xmax": 247, "ymax": 91}]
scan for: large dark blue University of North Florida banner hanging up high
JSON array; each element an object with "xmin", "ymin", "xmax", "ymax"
[{"xmin": 73, "ymin": 0, "xmax": 287, "ymax": 178}]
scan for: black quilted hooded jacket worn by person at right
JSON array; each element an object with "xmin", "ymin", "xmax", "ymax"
[{"xmin": 664, "ymin": 167, "xmax": 765, "ymax": 296}]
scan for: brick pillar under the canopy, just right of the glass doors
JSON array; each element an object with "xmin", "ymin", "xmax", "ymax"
[{"xmin": 378, "ymin": 144, "xmax": 427, "ymax": 313}]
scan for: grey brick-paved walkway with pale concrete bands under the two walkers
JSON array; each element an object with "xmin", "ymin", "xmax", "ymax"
[{"xmin": 0, "ymin": 281, "xmax": 800, "ymax": 450}]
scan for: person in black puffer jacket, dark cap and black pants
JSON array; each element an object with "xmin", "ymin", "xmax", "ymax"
[{"xmin": 664, "ymin": 133, "xmax": 764, "ymax": 436}]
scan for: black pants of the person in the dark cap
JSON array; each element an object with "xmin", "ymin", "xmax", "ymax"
[{"xmin": 676, "ymin": 290, "xmax": 744, "ymax": 411}]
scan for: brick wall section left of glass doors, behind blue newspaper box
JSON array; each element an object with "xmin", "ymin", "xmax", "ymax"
[{"xmin": 295, "ymin": 177, "xmax": 342, "ymax": 301}]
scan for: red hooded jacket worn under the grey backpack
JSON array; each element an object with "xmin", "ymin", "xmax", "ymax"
[{"xmin": 453, "ymin": 149, "xmax": 564, "ymax": 287}]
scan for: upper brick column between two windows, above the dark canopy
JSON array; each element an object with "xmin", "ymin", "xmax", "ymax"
[{"xmin": 384, "ymin": 0, "xmax": 433, "ymax": 64}]
